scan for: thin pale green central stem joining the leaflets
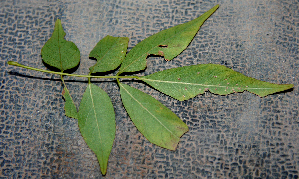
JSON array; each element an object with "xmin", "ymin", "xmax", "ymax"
[{"xmin": 7, "ymin": 61, "xmax": 139, "ymax": 79}]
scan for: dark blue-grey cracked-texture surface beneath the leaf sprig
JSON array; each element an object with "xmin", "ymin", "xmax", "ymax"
[{"xmin": 0, "ymin": 0, "xmax": 299, "ymax": 179}]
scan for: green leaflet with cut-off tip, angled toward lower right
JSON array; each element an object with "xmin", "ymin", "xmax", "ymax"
[{"xmin": 119, "ymin": 83, "xmax": 188, "ymax": 150}]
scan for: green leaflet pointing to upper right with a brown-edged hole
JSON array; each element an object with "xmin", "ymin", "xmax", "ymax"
[{"xmin": 118, "ymin": 5, "xmax": 219, "ymax": 74}]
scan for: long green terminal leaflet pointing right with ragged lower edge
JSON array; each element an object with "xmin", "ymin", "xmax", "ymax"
[{"xmin": 139, "ymin": 64, "xmax": 294, "ymax": 101}]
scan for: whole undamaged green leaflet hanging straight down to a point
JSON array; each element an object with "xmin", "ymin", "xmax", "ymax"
[{"xmin": 78, "ymin": 83, "xmax": 115, "ymax": 175}]
